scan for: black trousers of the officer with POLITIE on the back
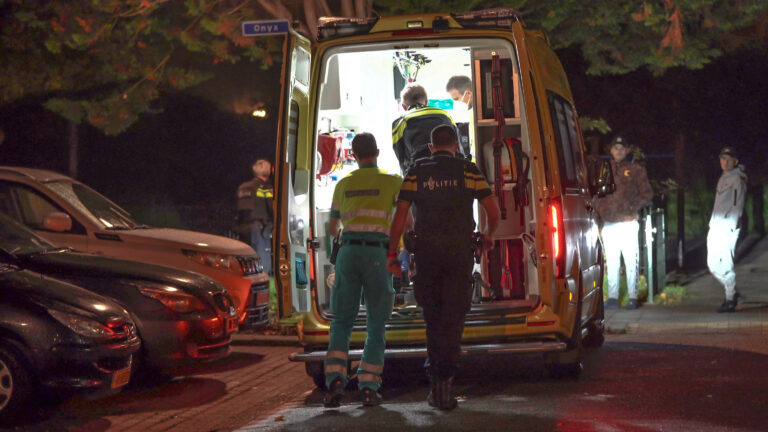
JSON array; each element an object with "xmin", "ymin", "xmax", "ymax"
[{"xmin": 413, "ymin": 245, "xmax": 473, "ymax": 379}]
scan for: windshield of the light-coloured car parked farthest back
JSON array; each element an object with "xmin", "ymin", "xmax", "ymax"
[{"xmin": 45, "ymin": 181, "xmax": 143, "ymax": 230}]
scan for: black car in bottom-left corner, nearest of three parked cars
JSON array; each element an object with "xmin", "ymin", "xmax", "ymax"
[{"xmin": 0, "ymin": 264, "xmax": 141, "ymax": 424}]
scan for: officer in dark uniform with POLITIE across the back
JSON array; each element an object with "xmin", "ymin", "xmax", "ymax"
[{"xmin": 387, "ymin": 125, "xmax": 499, "ymax": 409}]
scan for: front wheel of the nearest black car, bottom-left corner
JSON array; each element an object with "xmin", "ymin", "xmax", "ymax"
[{"xmin": 0, "ymin": 343, "xmax": 32, "ymax": 419}]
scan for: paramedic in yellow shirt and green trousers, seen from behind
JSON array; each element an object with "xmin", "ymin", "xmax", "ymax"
[{"xmin": 324, "ymin": 132, "xmax": 402, "ymax": 408}]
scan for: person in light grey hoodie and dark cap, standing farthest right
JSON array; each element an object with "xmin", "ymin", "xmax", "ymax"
[{"xmin": 707, "ymin": 147, "xmax": 747, "ymax": 312}]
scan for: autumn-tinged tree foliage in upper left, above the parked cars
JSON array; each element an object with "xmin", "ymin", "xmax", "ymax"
[{"xmin": 0, "ymin": 0, "xmax": 280, "ymax": 134}]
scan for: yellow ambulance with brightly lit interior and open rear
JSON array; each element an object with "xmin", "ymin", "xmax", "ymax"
[{"xmin": 274, "ymin": 8, "xmax": 610, "ymax": 386}]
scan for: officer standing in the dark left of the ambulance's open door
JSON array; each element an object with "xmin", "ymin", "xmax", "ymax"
[{"xmin": 235, "ymin": 158, "xmax": 274, "ymax": 275}]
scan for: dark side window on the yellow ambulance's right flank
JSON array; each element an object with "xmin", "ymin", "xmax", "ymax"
[{"xmin": 547, "ymin": 92, "xmax": 587, "ymax": 189}]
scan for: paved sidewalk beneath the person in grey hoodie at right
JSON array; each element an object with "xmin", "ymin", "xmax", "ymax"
[{"xmin": 606, "ymin": 237, "xmax": 768, "ymax": 339}]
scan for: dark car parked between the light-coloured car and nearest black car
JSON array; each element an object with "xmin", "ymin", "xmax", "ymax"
[{"xmin": 0, "ymin": 214, "xmax": 237, "ymax": 373}]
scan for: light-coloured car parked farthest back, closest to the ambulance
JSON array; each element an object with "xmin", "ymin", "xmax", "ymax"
[{"xmin": 0, "ymin": 166, "xmax": 269, "ymax": 325}]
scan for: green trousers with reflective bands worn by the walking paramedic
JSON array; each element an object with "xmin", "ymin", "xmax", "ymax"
[{"xmin": 325, "ymin": 232, "xmax": 395, "ymax": 390}]
